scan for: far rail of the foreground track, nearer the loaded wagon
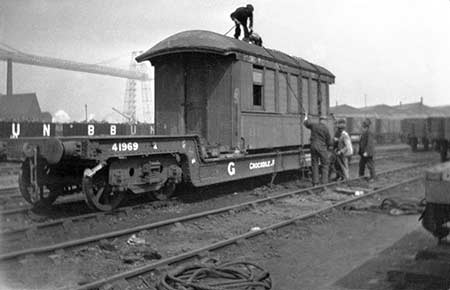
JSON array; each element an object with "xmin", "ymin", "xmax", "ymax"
[{"xmin": 0, "ymin": 164, "xmax": 423, "ymax": 261}]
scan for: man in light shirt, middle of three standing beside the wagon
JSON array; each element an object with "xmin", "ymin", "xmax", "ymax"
[{"xmin": 335, "ymin": 119, "xmax": 353, "ymax": 180}]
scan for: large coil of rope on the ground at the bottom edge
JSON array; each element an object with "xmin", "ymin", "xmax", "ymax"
[{"xmin": 157, "ymin": 262, "xmax": 272, "ymax": 290}]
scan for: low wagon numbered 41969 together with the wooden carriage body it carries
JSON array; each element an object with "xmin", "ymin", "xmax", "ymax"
[{"xmin": 9, "ymin": 31, "xmax": 335, "ymax": 210}]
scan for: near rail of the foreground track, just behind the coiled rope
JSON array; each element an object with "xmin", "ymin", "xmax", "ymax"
[{"xmin": 67, "ymin": 176, "xmax": 423, "ymax": 290}]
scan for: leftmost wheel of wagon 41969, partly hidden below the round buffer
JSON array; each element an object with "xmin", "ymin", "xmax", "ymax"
[{"xmin": 19, "ymin": 165, "xmax": 59, "ymax": 207}]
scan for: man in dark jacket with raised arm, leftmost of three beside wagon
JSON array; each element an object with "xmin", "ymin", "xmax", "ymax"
[{"xmin": 303, "ymin": 115, "xmax": 332, "ymax": 186}]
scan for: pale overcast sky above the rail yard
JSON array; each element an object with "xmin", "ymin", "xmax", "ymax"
[{"xmin": 0, "ymin": 0, "xmax": 450, "ymax": 120}]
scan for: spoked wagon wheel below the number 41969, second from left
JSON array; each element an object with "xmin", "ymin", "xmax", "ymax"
[{"xmin": 82, "ymin": 173, "xmax": 125, "ymax": 211}]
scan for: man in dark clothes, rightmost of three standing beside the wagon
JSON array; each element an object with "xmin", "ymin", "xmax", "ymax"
[{"xmin": 358, "ymin": 119, "xmax": 375, "ymax": 181}]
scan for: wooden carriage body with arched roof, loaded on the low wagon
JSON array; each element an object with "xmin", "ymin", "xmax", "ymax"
[{"xmin": 137, "ymin": 31, "xmax": 334, "ymax": 150}]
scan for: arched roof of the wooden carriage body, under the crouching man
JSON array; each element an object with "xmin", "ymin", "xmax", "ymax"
[{"xmin": 136, "ymin": 30, "xmax": 334, "ymax": 78}]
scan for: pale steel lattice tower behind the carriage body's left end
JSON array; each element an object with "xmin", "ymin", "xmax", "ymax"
[{"xmin": 123, "ymin": 51, "xmax": 153, "ymax": 123}]
